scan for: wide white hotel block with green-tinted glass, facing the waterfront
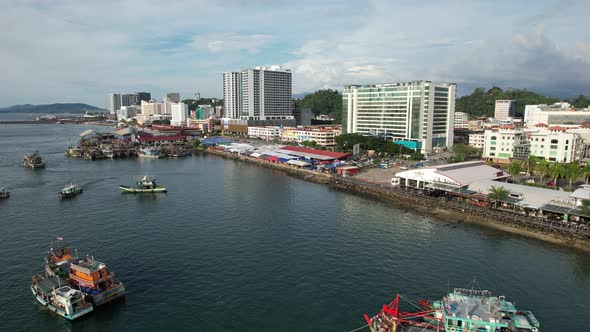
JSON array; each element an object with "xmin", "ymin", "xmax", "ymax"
[{"xmin": 342, "ymin": 81, "xmax": 457, "ymax": 153}]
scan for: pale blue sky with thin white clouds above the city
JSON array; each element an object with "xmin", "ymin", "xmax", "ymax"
[{"xmin": 0, "ymin": 0, "xmax": 590, "ymax": 108}]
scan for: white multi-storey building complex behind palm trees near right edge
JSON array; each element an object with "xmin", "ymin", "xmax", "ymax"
[{"xmin": 480, "ymin": 126, "xmax": 588, "ymax": 163}]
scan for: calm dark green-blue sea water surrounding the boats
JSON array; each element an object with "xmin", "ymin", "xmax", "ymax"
[{"xmin": 0, "ymin": 125, "xmax": 590, "ymax": 332}]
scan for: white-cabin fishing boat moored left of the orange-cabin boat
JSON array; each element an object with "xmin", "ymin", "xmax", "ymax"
[{"xmin": 31, "ymin": 275, "xmax": 94, "ymax": 320}]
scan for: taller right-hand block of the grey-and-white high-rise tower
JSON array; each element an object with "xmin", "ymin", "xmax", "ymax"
[{"xmin": 240, "ymin": 66, "xmax": 294, "ymax": 120}]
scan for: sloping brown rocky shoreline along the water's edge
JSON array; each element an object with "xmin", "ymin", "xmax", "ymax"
[{"xmin": 202, "ymin": 150, "xmax": 590, "ymax": 252}]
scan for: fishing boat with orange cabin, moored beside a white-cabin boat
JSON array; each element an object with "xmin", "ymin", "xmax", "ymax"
[{"xmin": 69, "ymin": 257, "xmax": 125, "ymax": 306}]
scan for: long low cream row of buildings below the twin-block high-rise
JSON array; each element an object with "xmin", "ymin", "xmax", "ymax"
[{"xmin": 248, "ymin": 126, "xmax": 342, "ymax": 146}]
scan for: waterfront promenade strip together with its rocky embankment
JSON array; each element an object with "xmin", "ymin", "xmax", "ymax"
[{"xmin": 206, "ymin": 148, "xmax": 590, "ymax": 251}]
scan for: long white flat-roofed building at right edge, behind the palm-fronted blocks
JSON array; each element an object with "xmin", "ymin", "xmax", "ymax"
[{"xmin": 524, "ymin": 102, "xmax": 590, "ymax": 128}]
